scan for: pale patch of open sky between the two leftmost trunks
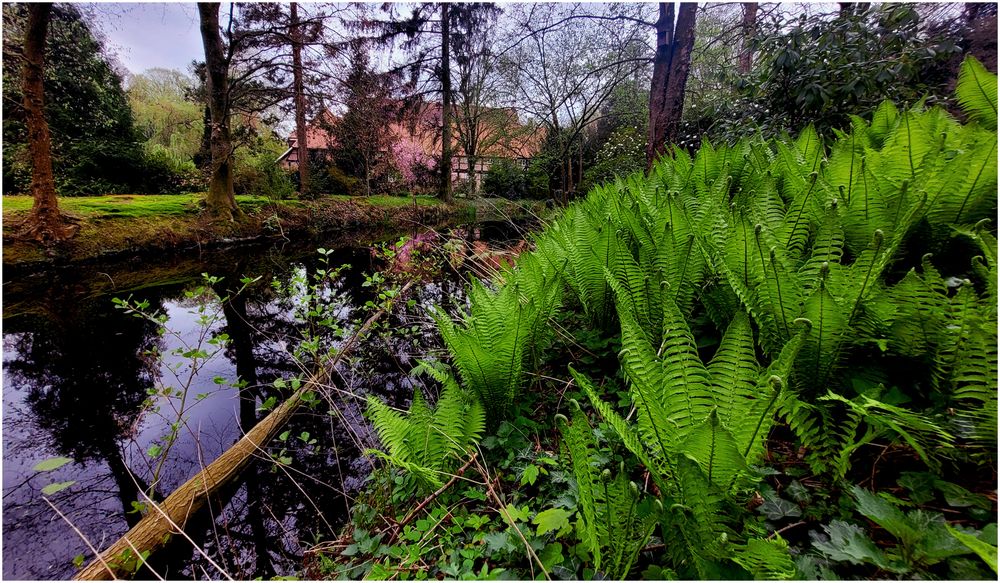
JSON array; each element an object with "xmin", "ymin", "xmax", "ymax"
[{"xmin": 93, "ymin": 2, "xmax": 205, "ymax": 78}]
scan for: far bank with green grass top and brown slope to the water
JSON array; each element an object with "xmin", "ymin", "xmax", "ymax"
[{"xmin": 3, "ymin": 194, "xmax": 490, "ymax": 268}]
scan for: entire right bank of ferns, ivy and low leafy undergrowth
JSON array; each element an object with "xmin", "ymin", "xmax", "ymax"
[{"xmin": 306, "ymin": 59, "xmax": 998, "ymax": 579}]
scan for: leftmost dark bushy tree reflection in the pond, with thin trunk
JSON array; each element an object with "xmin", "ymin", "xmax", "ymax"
[{"xmin": 4, "ymin": 286, "xmax": 161, "ymax": 524}]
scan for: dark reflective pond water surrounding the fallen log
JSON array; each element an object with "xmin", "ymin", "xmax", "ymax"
[{"xmin": 3, "ymin": 224, "xmax": 532, "ymax": 579}]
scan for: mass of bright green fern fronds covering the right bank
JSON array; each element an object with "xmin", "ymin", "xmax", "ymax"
[{"xmin": 372, "ymin": 54, "xmax": 997, "ymax": 579}]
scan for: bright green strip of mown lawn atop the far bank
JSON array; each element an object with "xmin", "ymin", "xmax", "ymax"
[{"xmin": 3, "ymin": 194, "xmax": 440, "ymax": 219}]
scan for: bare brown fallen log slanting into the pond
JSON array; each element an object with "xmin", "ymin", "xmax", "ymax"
[{"xmin": 73, "ymin": 282, "xmax": 413, "ymax": 581}]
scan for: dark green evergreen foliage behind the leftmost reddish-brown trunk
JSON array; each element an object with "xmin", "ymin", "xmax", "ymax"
[{"xmin": 3, "ymin": 4, "xmax": 150, "ymax": 196}]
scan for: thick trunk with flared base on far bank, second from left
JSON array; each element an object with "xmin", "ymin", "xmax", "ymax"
[{"xmin": 198, "ymin": 2, "xmax": 240, "ymax": 220}]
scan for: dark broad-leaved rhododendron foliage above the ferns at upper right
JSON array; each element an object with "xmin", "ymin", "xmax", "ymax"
[{"xmin": 682, "ymin": 3, "xmax": 962, "ymax": 146}]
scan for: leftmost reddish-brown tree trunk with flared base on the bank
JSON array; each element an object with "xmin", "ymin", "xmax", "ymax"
[{"xmin": 20, "ymin": 3, "xmax": 76, "ymax": 242}]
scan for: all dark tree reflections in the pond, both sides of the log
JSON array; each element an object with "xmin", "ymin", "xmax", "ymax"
[{"xmin": 5, "ymin": 222, "xmax": 532, "ymax": 579}]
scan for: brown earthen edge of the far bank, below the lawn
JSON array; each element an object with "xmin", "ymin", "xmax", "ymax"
[{"xmin": 3, "ymin": 198, "xmax": 536, "ymax": 271}]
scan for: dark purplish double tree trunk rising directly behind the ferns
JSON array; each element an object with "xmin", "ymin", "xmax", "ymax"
[{"xmin": 646, "ymin": 2, "xmax": 698, "ymax": 167}]
